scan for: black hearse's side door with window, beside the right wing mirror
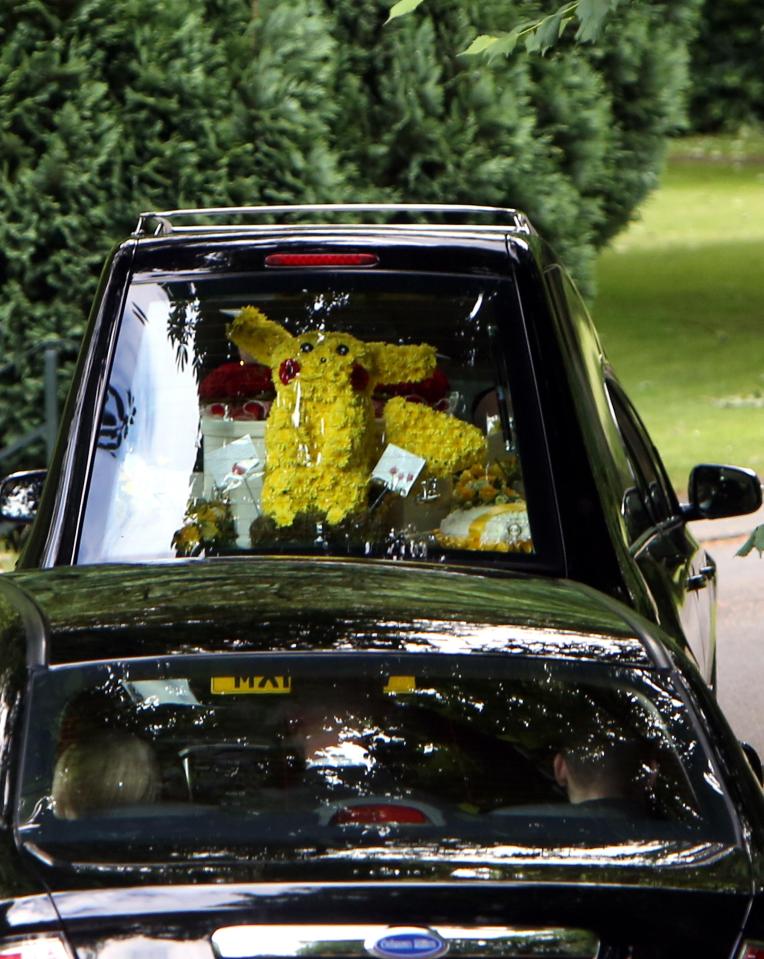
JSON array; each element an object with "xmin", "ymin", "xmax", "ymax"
[{"xmin": 607, "ymin": 377, "xmax": 716, "ymax": 683}]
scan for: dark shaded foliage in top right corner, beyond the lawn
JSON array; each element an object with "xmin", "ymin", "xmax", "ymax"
[{"xmin": 690, "ymin": 0, "xmax": 764, "ymax": 132}]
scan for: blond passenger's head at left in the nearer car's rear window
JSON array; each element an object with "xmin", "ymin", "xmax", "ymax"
[{"xmin": 52, "ymin": 730, "xmax": 160, "ymax": 819}]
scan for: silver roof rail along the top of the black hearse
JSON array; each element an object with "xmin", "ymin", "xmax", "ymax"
[{"xmin": 133, "ymin": 203, "xmax": 533, "ymax": 237}]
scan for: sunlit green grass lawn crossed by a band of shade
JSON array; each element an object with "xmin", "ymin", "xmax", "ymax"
[{"xmin": 593, "ymin": 134, "xmax": 764, "ymax": 490}]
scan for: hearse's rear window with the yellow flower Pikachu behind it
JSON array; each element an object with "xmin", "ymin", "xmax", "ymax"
[{"xmin": 77, "ymin": 270, "xmax": 553, "ymax": 563}]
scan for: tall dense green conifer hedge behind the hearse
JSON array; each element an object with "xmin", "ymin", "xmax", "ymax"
[{"xmin": 0, "ymin": 0, "xmax": 701, "ymax": 463}]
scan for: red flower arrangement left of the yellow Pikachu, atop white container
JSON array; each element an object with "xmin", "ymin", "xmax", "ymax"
[{"xmin": 199, "ymin": 360, "xmax": 276, "ymax": 420}]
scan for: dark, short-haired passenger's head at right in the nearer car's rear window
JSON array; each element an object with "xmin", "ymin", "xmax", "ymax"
[{"xmin": 553, "ymin": 740, "xmax": 655, "ymax": 817}]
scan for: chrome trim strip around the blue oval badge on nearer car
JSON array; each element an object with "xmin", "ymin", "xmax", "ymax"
[{"xmin": 211, "ymin": 924, "xmax": 600, "ymax": 959}]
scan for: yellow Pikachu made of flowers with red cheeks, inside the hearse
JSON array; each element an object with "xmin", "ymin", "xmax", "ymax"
[{"xmin": 228, "ymin": 306, "xmax": 485, "ymax": 526}]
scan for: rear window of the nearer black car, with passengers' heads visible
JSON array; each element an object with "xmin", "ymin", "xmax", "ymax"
[{"xmin": 17, "ymin": 653, "xmax": 734, "ymax": 875}]
